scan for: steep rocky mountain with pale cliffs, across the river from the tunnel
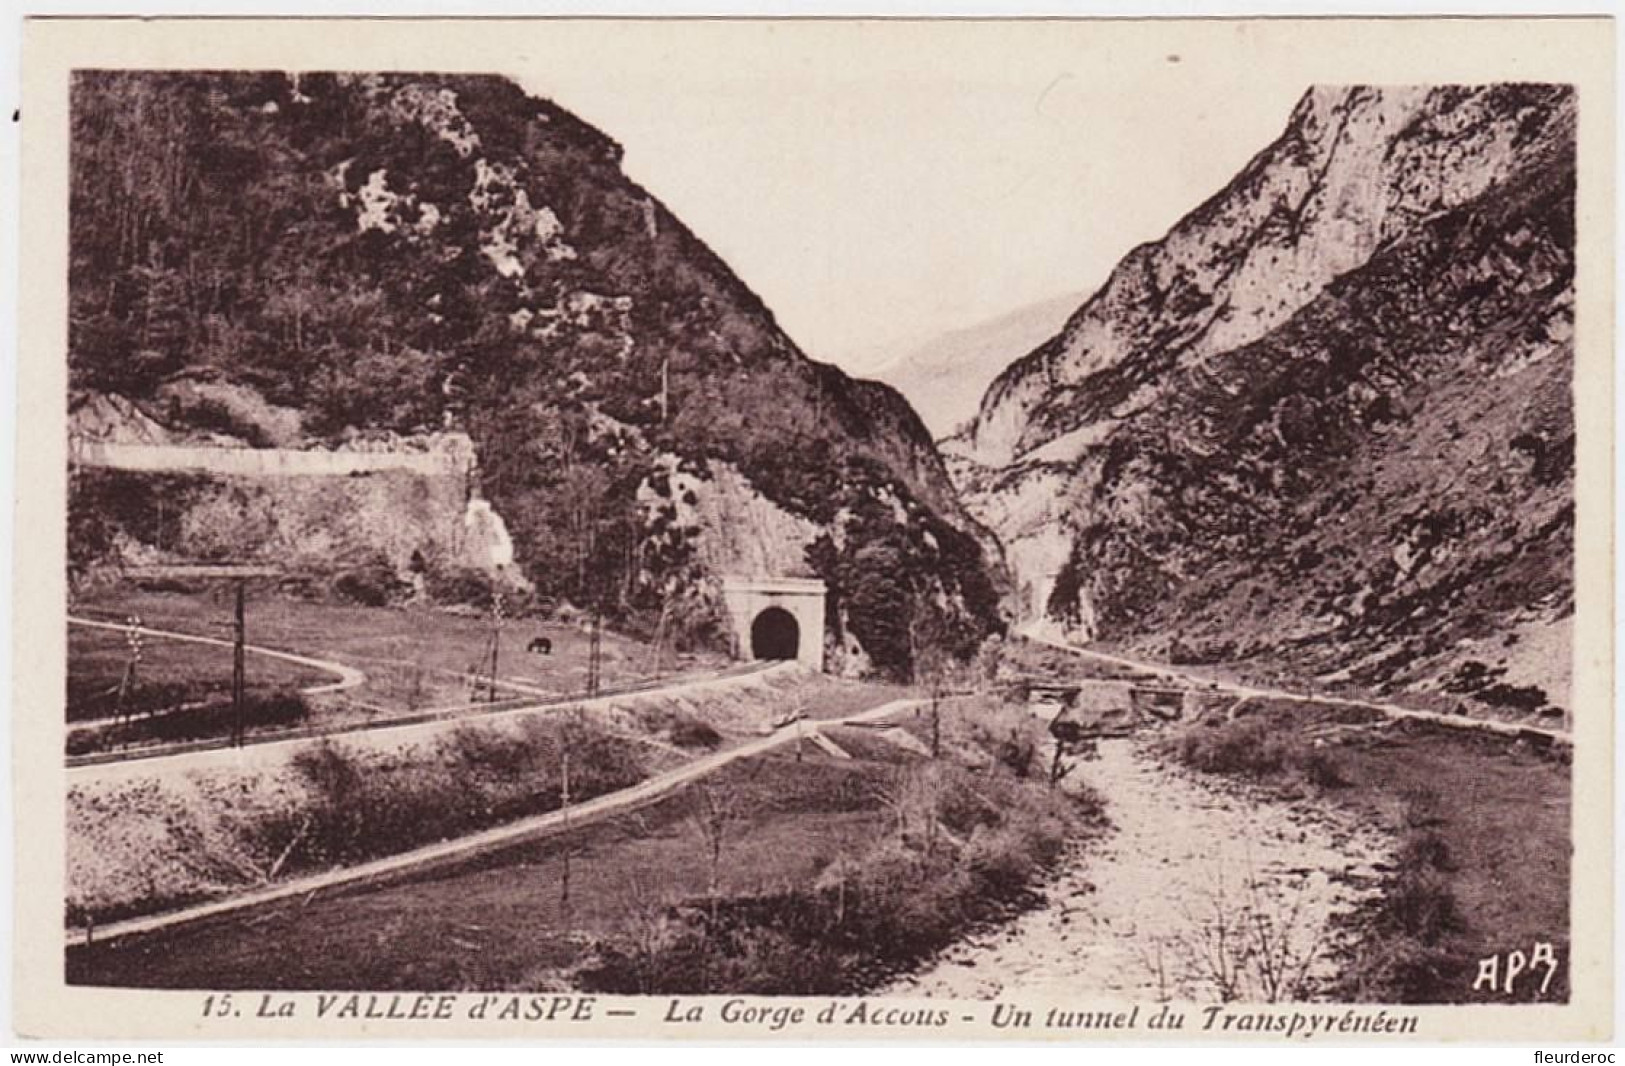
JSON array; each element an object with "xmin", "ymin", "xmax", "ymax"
[{"xmin": 947, "ymin": 85, "xmax": 1575, "ymax": 715}]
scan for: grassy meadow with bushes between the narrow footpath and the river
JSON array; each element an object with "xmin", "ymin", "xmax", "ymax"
[{"xmin": 67, "ymin": 683, "xmax": 1099, "ymax": 995}]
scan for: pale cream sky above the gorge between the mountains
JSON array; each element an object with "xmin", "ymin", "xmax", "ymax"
[{"xmin": 517, "ymin": 24, "xmax": 1308, "ymax": 374}]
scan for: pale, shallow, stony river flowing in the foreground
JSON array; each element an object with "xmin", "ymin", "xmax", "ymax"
[{"xmin": 886, "ymin": 739, "xmax": 1389, "ymax": 1001}]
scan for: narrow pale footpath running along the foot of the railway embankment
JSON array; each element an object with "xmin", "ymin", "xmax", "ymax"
[{"xmin": 67, "ymin": 692, "xmax": 926, "ymax": 947}]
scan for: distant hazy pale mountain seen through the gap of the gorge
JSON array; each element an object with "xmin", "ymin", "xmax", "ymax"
[{"xmin": 874, "ymin": 296, "xmax": 1077, "ymax": 437}]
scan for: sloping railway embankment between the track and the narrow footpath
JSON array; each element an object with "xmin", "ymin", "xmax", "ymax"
[{"xmin": 67, "ymin": 668, "xmax": 819, "ymax": 925}]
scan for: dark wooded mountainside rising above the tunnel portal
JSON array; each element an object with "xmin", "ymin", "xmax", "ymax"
[{"xmin": 68, "ymin": 72, "xmax": 1003, "ymax": 671}]
